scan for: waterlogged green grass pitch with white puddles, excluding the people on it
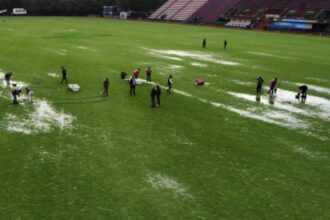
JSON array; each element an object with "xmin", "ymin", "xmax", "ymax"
[{"xmin": 0, "ymin": 17, "xmax": 330, "ymax": 220}]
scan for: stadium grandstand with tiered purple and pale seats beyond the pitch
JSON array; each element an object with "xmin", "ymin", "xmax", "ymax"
[{"xmin": 149, "ymin": 0, "xmax": 330, "ymax": 32}]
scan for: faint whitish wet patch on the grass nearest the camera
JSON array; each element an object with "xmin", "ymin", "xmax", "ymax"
[{"xmin": 146, "ymin": 174, "xmax": 193, "ymax": 198}]
